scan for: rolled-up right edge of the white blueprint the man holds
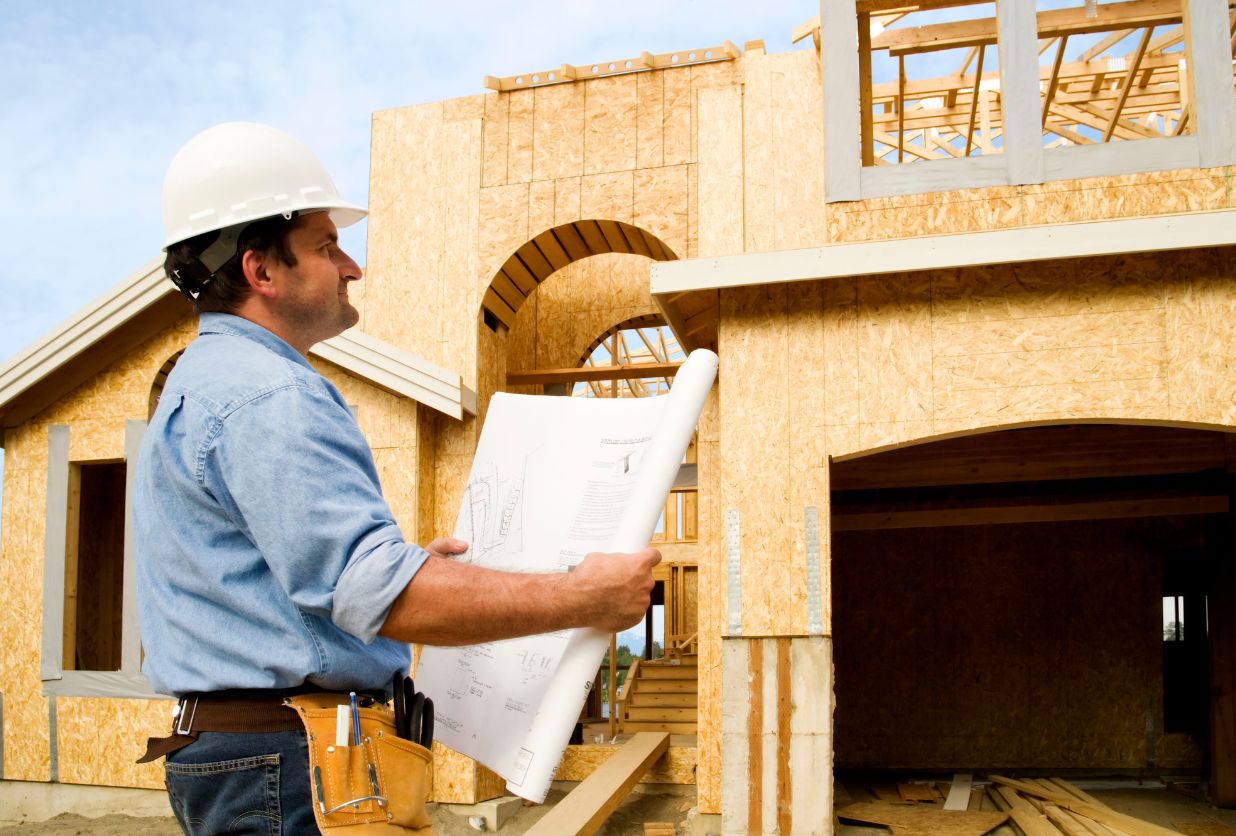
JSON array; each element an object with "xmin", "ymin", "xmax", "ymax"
[{"xmin": 507, "ymin": 349, "xmax": 717, "ymax": 803}]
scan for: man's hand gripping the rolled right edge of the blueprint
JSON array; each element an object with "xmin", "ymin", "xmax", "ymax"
[{"xmin": 569, "ymin": 548, "xmax": 661, "ymax": 633}]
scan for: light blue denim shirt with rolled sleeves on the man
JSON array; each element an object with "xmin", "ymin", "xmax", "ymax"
[{"xmin": 133, "ymin": 314, "xmax": 426, "ymax": 695}]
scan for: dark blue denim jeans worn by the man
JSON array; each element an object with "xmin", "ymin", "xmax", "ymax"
[{"xmin": 163, "ymin": 731, "xmax": 318, "ymax": 836}]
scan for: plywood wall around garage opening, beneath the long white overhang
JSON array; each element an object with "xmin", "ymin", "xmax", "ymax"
[{"xmin": 713, "ymin": 249, "xmax": 1236, "ymax": 634}]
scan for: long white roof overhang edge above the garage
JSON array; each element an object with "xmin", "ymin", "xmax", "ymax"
[{"xmin": 650, "ymin": 209, "xmax": 1236, "ymax": 343}]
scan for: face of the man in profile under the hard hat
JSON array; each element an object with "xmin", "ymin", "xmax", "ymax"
[{"xmin": 267, "ymin": 211, "xmax": 361, "ymax": 350}]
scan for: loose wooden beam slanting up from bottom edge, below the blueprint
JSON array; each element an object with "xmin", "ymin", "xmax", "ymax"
[{"xmin": 528, "ymin": 732, "xmax": 670, "ymax": 836}]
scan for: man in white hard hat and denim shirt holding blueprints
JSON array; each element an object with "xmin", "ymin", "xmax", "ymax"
[{"xmin": 133, "ymin": 122, "xmax": 660, "ymax": 834}]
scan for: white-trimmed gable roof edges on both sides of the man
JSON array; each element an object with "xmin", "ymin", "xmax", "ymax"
[{"xmin": 0, "ymin": 257, "xmax": 476, "ymax": 435}]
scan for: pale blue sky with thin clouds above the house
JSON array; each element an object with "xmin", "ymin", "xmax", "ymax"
[{"xmin": 0, "ymin": 0, "xmax": 819, "ymax": 499}]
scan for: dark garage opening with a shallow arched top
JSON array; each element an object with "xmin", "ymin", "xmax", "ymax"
[{"xmin": 831, "ymin": 424, "xmax": 1236, "ymax": 809}]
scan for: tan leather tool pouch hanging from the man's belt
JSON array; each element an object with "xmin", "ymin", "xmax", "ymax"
[{"xmin": 286, "ymin": 694, "xmax": 434, "ymax": 836}]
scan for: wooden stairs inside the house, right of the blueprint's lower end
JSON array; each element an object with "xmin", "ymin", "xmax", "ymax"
[{"xmin": 618, "ymin": 654, "xmax": 700, "ymax": 735}]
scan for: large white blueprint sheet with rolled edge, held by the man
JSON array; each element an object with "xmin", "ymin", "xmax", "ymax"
[{"xmin": 417, "ymin": 351, "xmax": 717, "ymax": 803}]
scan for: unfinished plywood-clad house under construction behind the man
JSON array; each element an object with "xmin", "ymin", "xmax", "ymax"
[{"xmin": 0, "ymin": 0, "xmax": 1236, "ymax": 834}]
